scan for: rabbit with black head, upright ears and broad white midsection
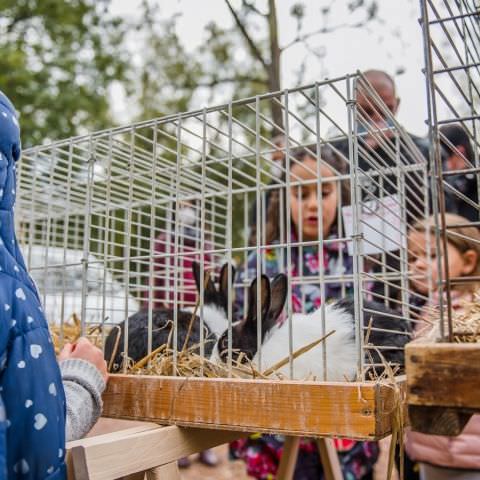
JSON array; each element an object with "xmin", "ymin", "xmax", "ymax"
[{"xmin": 211, "ymin": 274, "xmax": 410, "ymax": 381}]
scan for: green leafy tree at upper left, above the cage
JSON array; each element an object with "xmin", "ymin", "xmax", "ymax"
[{"xmin": 0, "ymin": 0, "xmax": 127, "ymax": 146}]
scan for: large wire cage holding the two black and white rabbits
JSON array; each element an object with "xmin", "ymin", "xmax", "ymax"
[{"xmin": 17, "ymin": 74, "xmax": 430, "ymax": 438}]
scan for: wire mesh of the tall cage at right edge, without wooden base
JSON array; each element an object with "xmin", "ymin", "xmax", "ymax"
[{"xmin": 421, "ymin": 0, "xmax": 480, "ymax": 341}]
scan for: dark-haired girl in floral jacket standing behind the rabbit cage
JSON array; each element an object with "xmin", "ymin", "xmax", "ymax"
[{"xmin": 231, "ymin": 148, "xmax": 378, "ymax": 480}]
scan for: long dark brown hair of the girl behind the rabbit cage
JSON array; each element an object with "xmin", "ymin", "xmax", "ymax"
[{"xmin": 250, "ymin": 146, "xmax": 350, "ymax": 245}]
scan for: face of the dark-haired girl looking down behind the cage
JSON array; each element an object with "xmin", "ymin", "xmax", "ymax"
[{"xmin": 290, "ymin": 157, "xmax": 340, "ymax": 240}]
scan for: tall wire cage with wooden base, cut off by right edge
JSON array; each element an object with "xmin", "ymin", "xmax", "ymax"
[{"xmin": 406, "ymin": 0, "xmax": 480, "ymax": 435}]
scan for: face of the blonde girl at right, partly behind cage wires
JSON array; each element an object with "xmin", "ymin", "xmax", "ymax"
[{"xmin": 408, "ymin": 231, "xmax": 479, "ymax": 295}]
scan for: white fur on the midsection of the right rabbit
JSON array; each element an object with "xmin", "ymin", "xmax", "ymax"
[{"xmin": 253, "ymin": 304, "xmax": 357, "ymax": 382}]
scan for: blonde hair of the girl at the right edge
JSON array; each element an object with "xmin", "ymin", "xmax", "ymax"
[{"xmin": 410, "ymin": 213, "xmax": 480, "ymax": 292}]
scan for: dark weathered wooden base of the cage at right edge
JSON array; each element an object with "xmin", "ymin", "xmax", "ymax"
[{"xmin": 405, "ymin": 342, "xmax": 480, "ymax": 435}]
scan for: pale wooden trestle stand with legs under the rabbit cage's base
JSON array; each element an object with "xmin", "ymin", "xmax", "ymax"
[{"xmin": 66, "ymin": 418, "xmax": 343, "ymax": 480}]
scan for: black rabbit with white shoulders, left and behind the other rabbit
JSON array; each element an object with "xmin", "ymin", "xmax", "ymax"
[{"xmin": 104, "ymin": 262, "xmax": 235, "ymax": 371}]
